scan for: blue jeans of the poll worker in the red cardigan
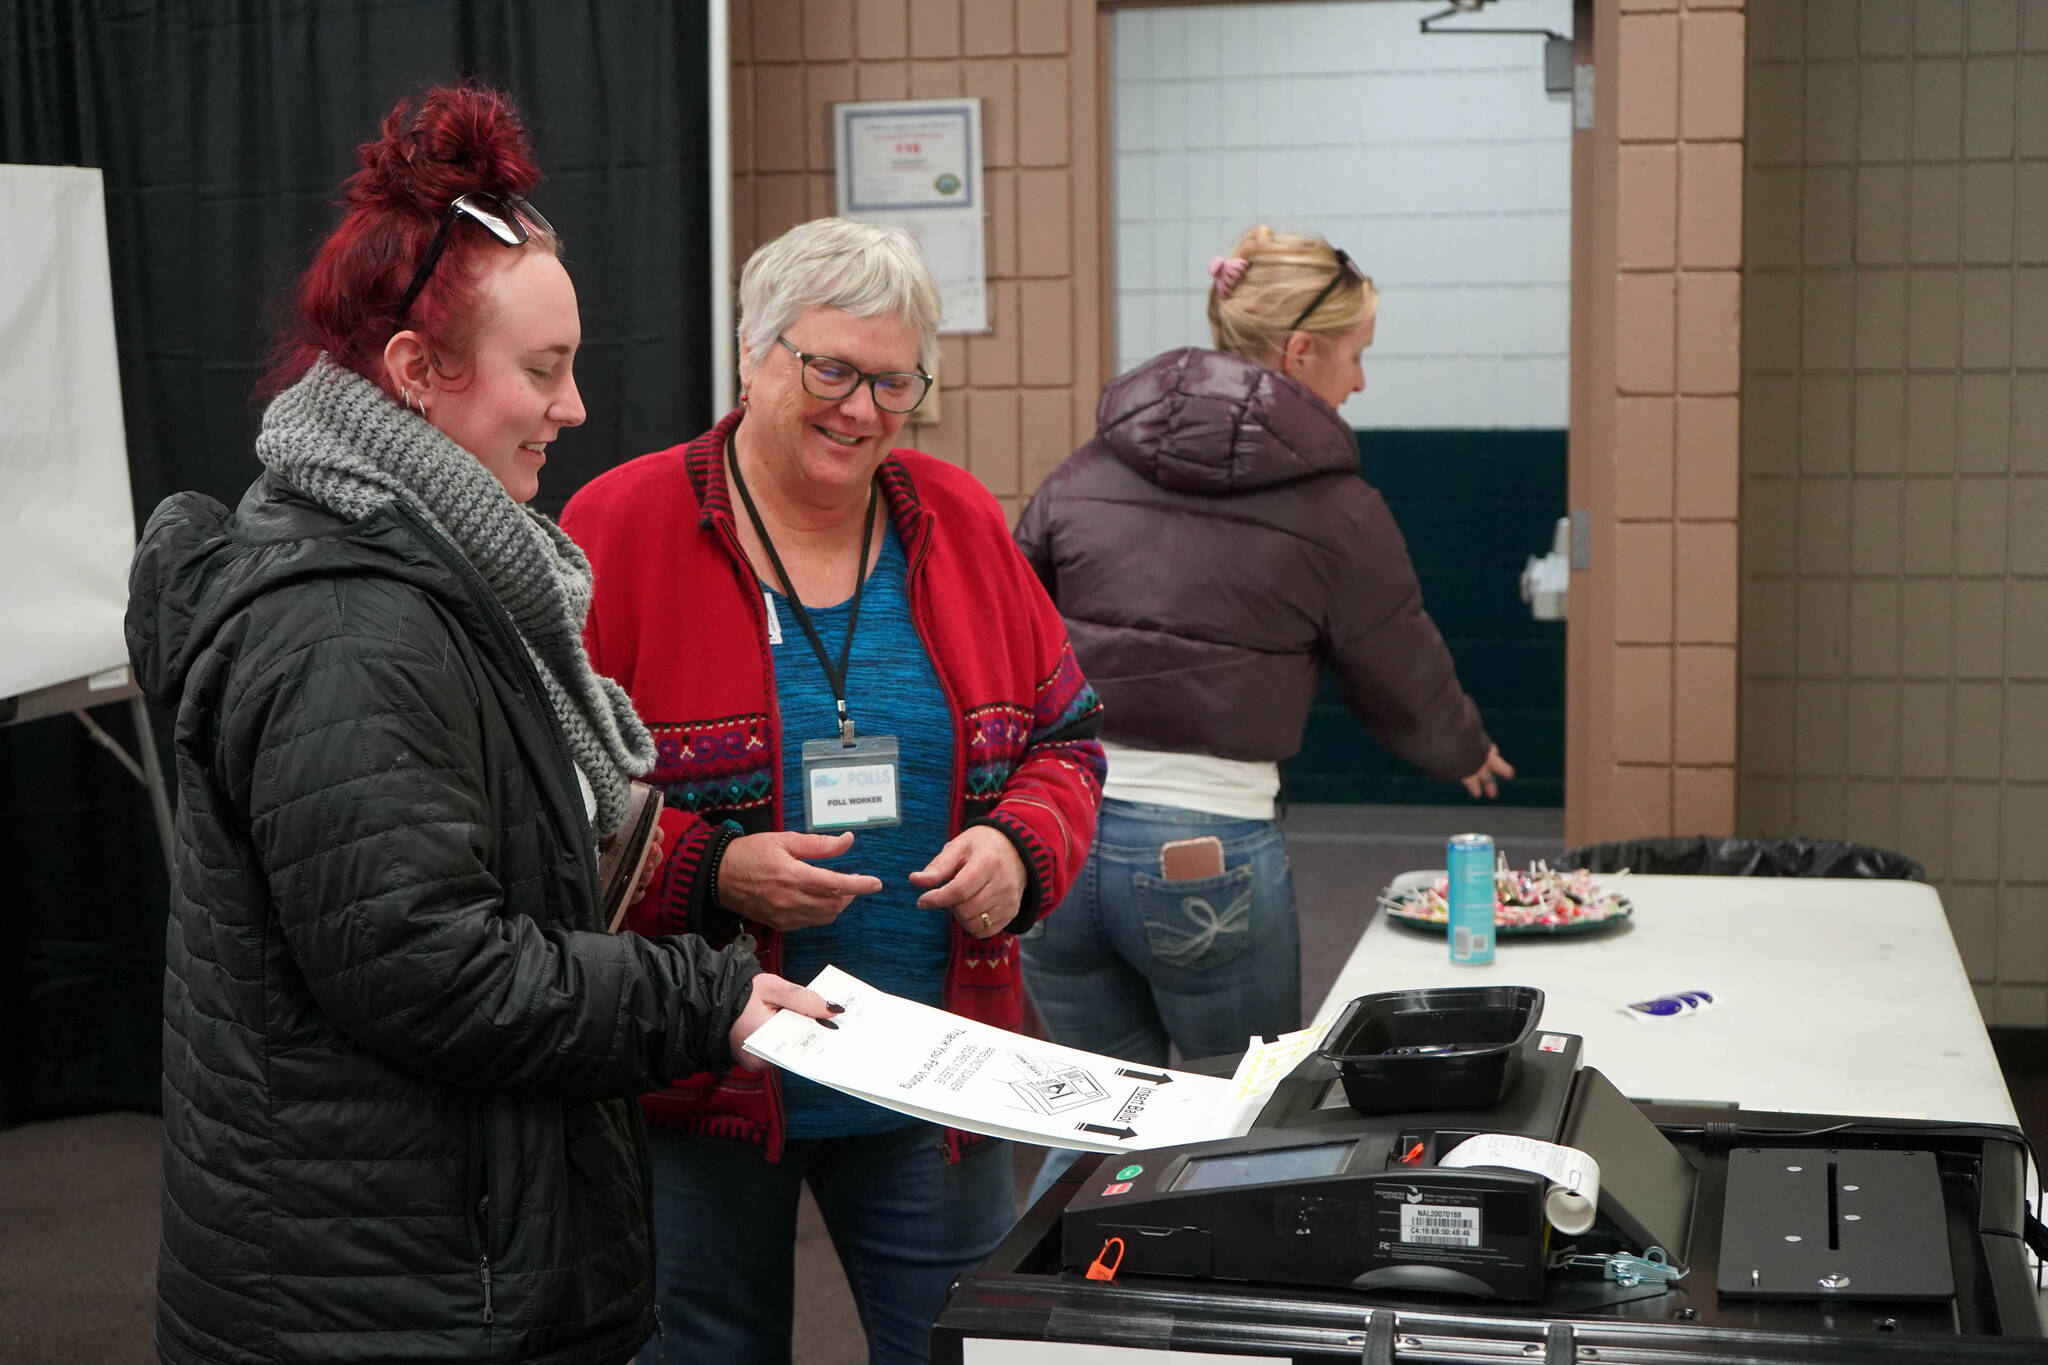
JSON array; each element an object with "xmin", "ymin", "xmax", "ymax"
[{"xmin": 639, "ymin": 1124, "xmax": 1016, "ymax": 1365}]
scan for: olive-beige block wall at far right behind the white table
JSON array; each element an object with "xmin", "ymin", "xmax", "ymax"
[{"xmin": 1741, "ymin": 0, "xmax": 2048, "ymax": 1025}]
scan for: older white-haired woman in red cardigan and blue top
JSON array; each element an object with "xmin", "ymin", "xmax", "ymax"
[{"xmin": 561, "ymin": 219, "xmax": 1102, "ymax": 1361}]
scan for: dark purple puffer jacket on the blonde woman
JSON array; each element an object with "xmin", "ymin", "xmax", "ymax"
[{"xmin": 1016, "ymin": 346, "xmax": 1489, "ymax": 782}]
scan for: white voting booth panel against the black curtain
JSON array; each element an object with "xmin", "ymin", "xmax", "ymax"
[{"xmin": 0, "ymin": 166, "xmax": 170, "ymax": 860}]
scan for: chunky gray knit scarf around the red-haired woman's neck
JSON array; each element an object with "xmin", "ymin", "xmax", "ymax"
[{"xmin": 256, "ymin": 356, "xmax": 655, "ymax": 835}]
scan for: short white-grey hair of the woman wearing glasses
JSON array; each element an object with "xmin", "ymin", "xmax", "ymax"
[{"xmin": 739, "ymin": 219, "xmax": 940, "ymax": 370}]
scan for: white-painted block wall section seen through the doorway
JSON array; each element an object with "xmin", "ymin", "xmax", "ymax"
[{"xmin": 1110, "ymin": 0, "xmax": 1571, "ymax": 428}]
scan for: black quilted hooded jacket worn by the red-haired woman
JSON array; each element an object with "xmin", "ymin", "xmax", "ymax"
[{"xmin": 127, "ymin": 475, "xmax": 756, "ymax": 1365}]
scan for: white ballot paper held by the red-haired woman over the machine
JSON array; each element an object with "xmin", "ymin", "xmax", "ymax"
[{"xmin": 745, "ymin": 966, "xmax": 1321, "ymax": 1152}]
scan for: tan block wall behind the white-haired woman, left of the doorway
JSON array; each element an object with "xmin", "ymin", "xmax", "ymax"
[{"xmin": 729, "ymin": 0, "xmax": 1104, "ymax": 520}]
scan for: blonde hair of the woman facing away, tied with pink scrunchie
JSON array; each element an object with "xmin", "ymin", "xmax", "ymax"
[{"xmin": 1208, "ymin": 223, "xmax": 1380, "ymax": 364}]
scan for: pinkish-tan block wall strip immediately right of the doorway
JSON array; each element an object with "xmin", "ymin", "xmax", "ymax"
[{"xmin": 1567, "ymin": 0, "xmax": 1745, "ymax": 839}]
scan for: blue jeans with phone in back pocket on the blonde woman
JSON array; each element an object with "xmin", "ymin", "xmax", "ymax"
[{"xmin": 1022, "ymin": 800, "xmax": 1300, "ymax": 1201}]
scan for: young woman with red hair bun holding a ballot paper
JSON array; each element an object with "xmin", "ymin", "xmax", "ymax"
[{"xmin": 127, "ymin": 86, "xmax": 827, "ymax": 1365}]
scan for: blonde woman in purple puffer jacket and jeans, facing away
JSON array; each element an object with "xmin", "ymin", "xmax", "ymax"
[{"xmin": 1016, "ymin": 227, "xmax": 1513, "ymax": 1179}]
